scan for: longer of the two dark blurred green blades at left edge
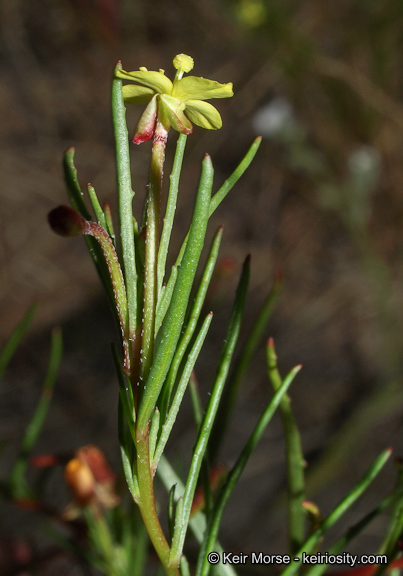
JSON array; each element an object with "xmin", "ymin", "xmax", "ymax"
[{"xmin": 10, "ymin": 328, "xmax": 63, "ymax": 497}]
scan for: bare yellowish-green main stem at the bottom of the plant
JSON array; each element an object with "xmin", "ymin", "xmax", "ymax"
[{"xmin": 136, "ymin": 428, "xmax": 180, "ymax": 576}]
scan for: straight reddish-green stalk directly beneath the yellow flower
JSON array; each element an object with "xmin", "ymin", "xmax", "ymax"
[{"xmin": 140, "ymin": 121, "xmax": 168, "ymax": 384}]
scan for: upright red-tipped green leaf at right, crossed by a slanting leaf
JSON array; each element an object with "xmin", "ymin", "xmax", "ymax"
[{"xmin": 266, "ymin": 339, "xmax": 306, "ymax": 555}]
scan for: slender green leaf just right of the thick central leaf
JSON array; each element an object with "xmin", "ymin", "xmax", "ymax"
[{"xmin": 160, "ymin": 227, "xmax": 223, "ymax": 423}]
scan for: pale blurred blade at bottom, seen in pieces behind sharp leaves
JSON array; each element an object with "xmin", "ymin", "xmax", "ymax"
[{"xmin": 157, "ymin": 455, "xmax": 240, "ymax": 576}]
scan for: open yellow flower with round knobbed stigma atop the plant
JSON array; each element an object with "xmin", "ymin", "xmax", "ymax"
[{"xmin": 116, "ymin": 54, "xmax": 234, "ymax": 144}]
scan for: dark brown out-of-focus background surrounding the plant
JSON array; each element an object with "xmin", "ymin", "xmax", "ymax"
[{"xmin": 0, "ymin": 0, "xmax": 403, "ymax": 574}]
